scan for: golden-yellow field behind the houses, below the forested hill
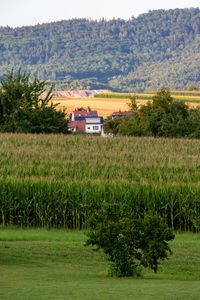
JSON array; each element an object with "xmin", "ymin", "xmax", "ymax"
[{"xmin": 53, "ymin": 91, "xmax": 200, "ymax": 118}]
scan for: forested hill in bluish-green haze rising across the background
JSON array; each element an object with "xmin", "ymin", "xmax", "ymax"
[{"xmin": 0, "ymin": 8, "xmax": 200, "ymax": 92}]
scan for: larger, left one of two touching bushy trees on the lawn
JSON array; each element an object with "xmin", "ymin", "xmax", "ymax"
[{"xmin": 86, "ymin": 204, "xmax": 140, "ymax": 277}]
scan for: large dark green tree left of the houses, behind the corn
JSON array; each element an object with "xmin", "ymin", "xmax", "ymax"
[{"xmin": 0, "ymin": 69, "xmax": 67, "ymax": 133}]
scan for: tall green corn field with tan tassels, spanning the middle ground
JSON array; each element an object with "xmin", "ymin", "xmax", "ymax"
[{"xmin": 0, "ymin": 134, "xmax": 200, "ymax": 231}]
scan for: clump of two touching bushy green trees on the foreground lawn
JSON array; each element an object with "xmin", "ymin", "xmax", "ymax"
[{"xmin": 86, "ymin": 204, "xmax": 174, "ymax": 277}]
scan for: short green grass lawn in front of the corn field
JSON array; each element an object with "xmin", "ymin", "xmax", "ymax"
[{"xmin": 0, "ymin": 228, "xmax": 200, "ymax": 300}]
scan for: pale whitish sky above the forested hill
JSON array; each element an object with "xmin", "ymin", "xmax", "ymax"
[{"xmin": 0, "ymin": 0, "xmax": 200, "ymax": 27}]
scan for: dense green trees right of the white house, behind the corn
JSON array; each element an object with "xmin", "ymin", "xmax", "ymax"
[{"xmin": 104, "ymin": 89, "xmax": 200, "ymax": 138}]
